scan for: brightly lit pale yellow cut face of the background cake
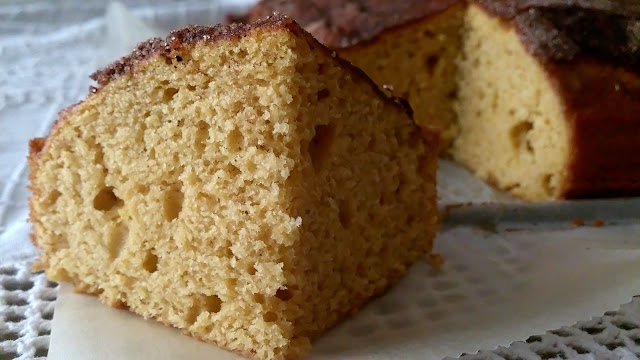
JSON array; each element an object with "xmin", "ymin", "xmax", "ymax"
[{"xmin": 450, "ymin": 4, "xmax": 570, "ymax": 201}]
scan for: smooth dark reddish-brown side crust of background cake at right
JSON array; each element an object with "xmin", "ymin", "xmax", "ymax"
[{"xmin": 545, "ymin": 59, "xmax": 640, "ymax": 199}]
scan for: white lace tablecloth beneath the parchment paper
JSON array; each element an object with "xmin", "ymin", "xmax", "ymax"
[{"xmin": 0, "ymin": 0, "xmax": 640, "ymax": 360}]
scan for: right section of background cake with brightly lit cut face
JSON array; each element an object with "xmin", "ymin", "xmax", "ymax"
[{"xmin": 451, "ymin": 0, "xmax": 640, "ymax": 201}]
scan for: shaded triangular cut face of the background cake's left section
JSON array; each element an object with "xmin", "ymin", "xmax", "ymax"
[{"xmin": 339, "ymin": 4, "xmax": 466, "ymax": 149}]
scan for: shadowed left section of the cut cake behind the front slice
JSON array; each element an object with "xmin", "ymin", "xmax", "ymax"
[{"xmin": 239, "ymin": 0, "xmax": 465, "ymax": 149}]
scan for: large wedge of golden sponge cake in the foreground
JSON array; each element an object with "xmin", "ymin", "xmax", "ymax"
[{"xmin": 29, "ymin": 15, "xmax": 438, "ymax": 360}]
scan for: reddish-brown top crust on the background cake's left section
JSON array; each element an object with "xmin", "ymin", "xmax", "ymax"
[{"xmin": 239, "ymin": 0, "xmax": 463, "ymax": 50}]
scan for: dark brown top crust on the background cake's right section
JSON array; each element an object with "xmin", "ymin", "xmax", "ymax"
[{"xmin": 473, "ymin": 0, "xmax": 640, "ymax": 72}]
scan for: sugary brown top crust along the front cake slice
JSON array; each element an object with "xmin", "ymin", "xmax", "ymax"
[{"xmin": 91, "ymin": 14, "xmax": 292, "ymax": 88}]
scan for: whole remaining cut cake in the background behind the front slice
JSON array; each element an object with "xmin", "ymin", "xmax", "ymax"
[{"xmin": 240, "ymin": 0, "xmax": 640, "ymax": 201}]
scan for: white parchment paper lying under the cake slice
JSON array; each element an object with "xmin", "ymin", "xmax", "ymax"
[{"xmin": 49, "ymin": 2, "xmax": 640, "ymax": 360}]
